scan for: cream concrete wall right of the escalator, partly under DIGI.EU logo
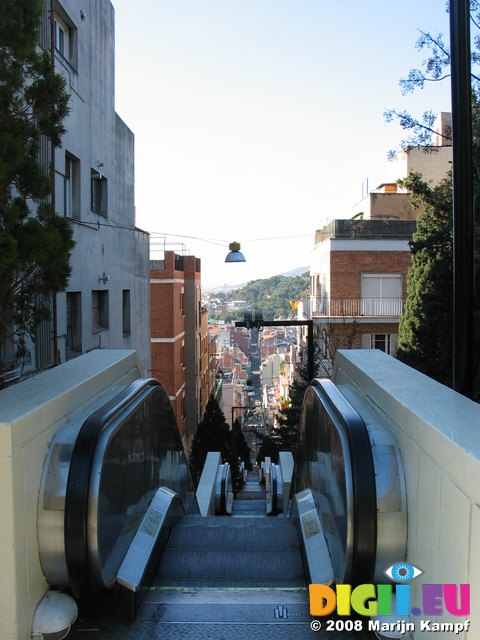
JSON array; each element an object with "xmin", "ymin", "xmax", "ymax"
[{"xmin": 333, "ymin": 350, "xmax": 480, "ymax": 640}]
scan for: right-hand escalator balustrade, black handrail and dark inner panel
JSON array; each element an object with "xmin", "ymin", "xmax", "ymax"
[{"xmin": 295, "ymin": 380, "xmax": 377, "ymax": 585}]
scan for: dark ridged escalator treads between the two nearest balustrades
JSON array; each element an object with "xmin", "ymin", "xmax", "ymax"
[{"xmin": 154, "ymin": 516, "xmax": 305, "ymax": 589}]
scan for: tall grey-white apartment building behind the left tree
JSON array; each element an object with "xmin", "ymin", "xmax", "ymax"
[{"xmin": 24, "ymin": 0, "xmax": 150, "ymax": 372}]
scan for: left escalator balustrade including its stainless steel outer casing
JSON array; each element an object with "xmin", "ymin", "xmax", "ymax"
[{"xmin": 39, "ymin": 379, "xmax": 198, "ymax": 599}]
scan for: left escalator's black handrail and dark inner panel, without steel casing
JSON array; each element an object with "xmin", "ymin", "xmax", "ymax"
[{"xmin": 65, "ymin": 380, "xmax": 197, "ymax": 599}]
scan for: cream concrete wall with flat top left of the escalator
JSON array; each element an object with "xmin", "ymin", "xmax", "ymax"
[{"xmin": 0, "ymin": 350, "xmax": 141, "ymax": 640}]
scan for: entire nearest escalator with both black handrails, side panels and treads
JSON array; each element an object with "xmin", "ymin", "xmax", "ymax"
[{"xmin": 38, "ymin": 380, "xmax": 406, "ymax": 640}]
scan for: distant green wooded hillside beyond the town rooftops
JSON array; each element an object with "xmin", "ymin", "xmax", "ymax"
[{"xmin": 225, "ymin": 271, "xmax": 310, "ymax": 320}]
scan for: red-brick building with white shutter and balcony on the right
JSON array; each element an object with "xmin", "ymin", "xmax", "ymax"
[{"xmin": 299, "ymin": 220, "xmax": 415, "ymax": 375}]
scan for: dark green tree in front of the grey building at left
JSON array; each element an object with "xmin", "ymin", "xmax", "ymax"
[{"xmin": 0, "ymin": 0, "xmax": 74, "ymax": 372}]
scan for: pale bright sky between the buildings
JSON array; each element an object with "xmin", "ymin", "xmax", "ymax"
[{"xmin": 112, "ymin": 0, "xmax": 450, "ymax": 288}]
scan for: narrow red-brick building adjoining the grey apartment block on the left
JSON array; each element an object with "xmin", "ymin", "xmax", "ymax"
[{"xmin": 150, "ymin": 251, "xmax": 215, "ymax": 451}]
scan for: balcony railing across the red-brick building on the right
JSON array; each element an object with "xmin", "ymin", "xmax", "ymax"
[{"xmin": 304, "ymin": 296, "xmax": 405, "ymax": 318}]
